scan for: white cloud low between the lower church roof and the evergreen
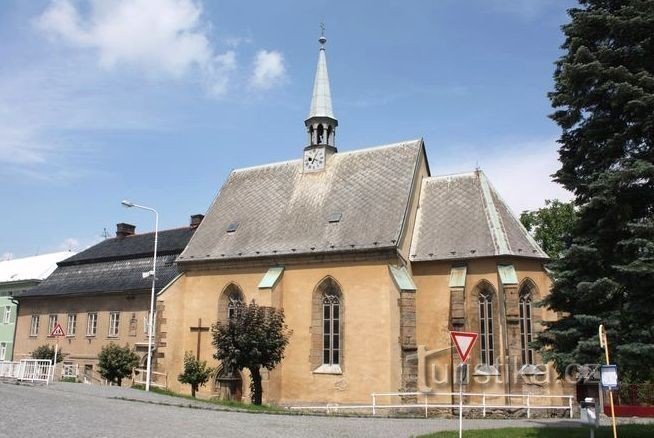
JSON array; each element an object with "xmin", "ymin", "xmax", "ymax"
[{"xmin": 432, "ymin": 139, "xmax": 572, "ymax": 214}]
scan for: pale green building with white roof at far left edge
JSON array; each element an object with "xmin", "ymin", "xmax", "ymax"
[{"xmin": 0, "ymin": 251, "xmax": 75, "ymax": 361}]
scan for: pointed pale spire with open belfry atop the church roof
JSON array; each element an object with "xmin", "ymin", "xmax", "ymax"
[{"xmin": 304, "ymin": 25, "xmax": 338, "ymax": 149}]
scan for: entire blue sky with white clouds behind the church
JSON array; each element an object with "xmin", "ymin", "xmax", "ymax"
[{"xmin": 0, "ymin": 0, "xmax": 573, "ymax": 258}]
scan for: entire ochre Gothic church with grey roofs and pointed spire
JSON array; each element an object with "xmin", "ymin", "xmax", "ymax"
[{"xmin": 156, "ymin": 37, "xmax": 569, "ymax": 405}]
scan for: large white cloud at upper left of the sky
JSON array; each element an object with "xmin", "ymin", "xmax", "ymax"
[{"xmin": 36, "ymin": 0, "xmax": 236, "ymax": 95}]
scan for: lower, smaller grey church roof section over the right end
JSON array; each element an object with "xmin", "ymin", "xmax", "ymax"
[{"xmin": 410, "ymin": 171, "xmax": 548, "ymax": 261}]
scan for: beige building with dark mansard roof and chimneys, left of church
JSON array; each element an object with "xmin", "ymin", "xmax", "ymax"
[{"xmin": 14, "ymin": 215, "xmax": 202, "ymax": 382}]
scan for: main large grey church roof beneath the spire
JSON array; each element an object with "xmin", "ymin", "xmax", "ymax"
[{"xmin": 179, "ymin": 140, "xmax": 423, "ymax": 262}]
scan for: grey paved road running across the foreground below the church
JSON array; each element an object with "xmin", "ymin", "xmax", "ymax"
[{"xmin": 0, "ymin": 383, "xmax": 644, "ymax": 438}]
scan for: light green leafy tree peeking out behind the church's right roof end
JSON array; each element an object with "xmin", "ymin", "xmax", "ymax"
[{"xmin": 520, "ymin": 199, "xmax": 576, "ymax": 259}]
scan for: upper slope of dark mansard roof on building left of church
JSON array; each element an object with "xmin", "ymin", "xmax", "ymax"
[{"xmin": 59, "ymin": 227, "xmax": 195, "ymax": 266}]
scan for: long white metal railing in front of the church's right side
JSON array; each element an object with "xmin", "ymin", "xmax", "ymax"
[{"xmin": 290, "ymin": 392, "xmax": 574, "ymax": 418}]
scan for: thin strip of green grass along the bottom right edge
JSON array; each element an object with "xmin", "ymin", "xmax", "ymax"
[{"xmin": 421, "ymin": 424, "xmax": 654, "ymax": 438}]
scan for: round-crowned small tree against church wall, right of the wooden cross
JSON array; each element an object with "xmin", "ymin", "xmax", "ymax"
[{"xmin": 211, "ymin": 301, "xmax": 291, "ymax": 405}]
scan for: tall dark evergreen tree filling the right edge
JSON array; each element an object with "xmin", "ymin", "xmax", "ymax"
[{"xmin": 537, "ymin": 0, "xmax": 654, "ymax": 381}]
